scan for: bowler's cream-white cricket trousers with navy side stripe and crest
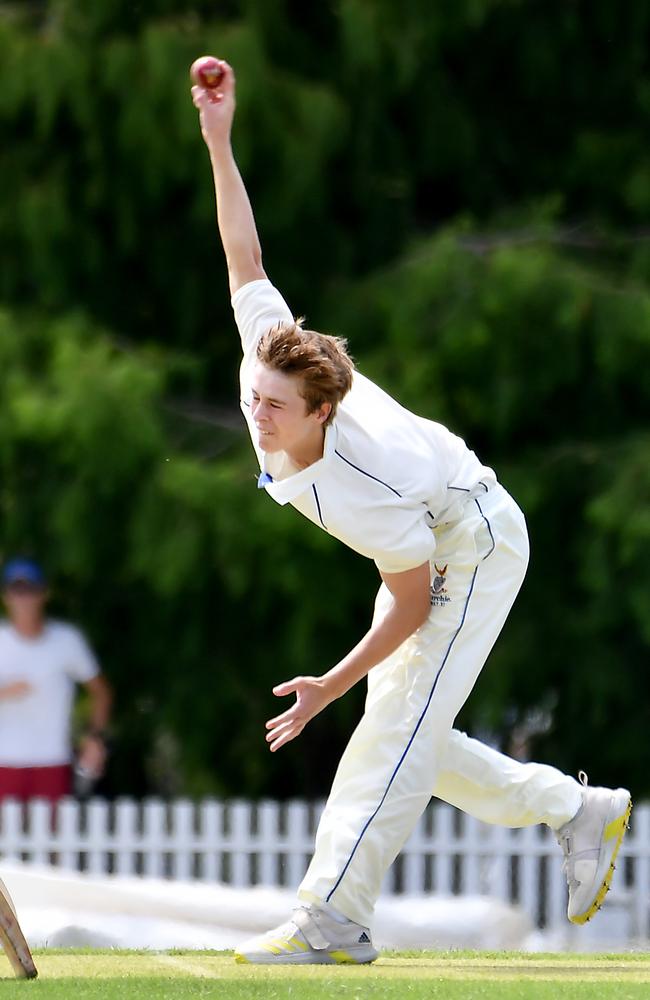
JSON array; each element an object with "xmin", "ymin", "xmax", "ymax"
[{"xmin": 298, "ymin": 485, "xmax": 582, "ymax": 927}]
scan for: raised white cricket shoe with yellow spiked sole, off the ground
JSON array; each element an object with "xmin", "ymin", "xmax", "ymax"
[{"xmin": 556, "ymin": 771, "xmax": 632, "ymax": 924}]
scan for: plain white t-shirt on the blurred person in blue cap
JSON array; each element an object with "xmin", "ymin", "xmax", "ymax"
[{"xmin": 0, "ymin": 621, "xmax": 99, "ymax": 767}]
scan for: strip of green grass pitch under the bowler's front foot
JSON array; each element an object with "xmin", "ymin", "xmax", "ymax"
[{"xmin": 0, "ymin": 950, "xmax": 650, "ymax": 1000}]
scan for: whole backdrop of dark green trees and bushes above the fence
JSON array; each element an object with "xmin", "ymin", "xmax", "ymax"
[{"xmin": 0, "ymin": 0, "xmax": 650, "ymax": 795}]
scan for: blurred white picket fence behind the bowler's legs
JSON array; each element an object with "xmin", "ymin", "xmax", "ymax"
[{"xmin": 0, "ymin": 799, "xmax": 650, "ymax": 940}]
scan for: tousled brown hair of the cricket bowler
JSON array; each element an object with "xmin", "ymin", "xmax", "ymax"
[{"xmin": 257, "ymin": 319, "xmax": 354, "ymax": 426}]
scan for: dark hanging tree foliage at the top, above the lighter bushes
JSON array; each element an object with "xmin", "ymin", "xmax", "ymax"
[{"xmin": 0, "ymin": 0, "xmax": 650, "ymax": 378}]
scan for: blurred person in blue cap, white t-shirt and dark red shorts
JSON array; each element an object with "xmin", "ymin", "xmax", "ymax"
[{"xmin": 0, "ymin": 558, "xmax": 112, "ymax": 802}]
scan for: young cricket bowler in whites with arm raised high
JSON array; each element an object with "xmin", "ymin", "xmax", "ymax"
[{"xmin": 192, "ymin": 62, "xmax": 631, "ymax": 964}]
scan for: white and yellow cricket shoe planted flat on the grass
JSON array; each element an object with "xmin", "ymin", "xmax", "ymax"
[{"xmin": 235, "ymin": 906, "xmax": 378, "ymax": 965}]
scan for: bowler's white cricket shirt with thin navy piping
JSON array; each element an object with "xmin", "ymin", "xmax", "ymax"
[{"xmin": 232, "ymin": 279, "xmax": 496, "ymax": 573}]
